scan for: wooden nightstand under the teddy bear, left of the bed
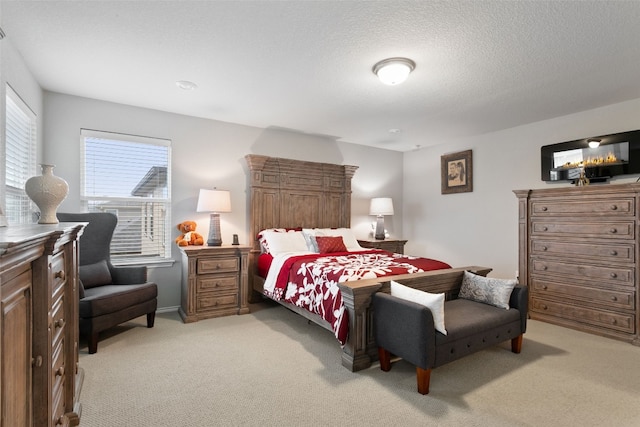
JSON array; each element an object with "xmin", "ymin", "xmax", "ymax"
[{"xmin": 179, "ymin": 246, "xmax": 251, "ymax": 323}]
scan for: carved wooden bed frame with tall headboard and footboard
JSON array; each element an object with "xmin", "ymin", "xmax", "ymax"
[{"xmin": 245, "ymin": 154, "xmax": 491, "ymax": 371}]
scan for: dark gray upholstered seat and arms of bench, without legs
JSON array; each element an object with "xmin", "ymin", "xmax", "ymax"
[{"xmin": 373, "ymin": 286, "xmax": 528, "ymax": 394}]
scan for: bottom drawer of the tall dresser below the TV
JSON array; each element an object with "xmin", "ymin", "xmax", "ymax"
[{"xmin": 531, "ymin": 296, "xmax": 635, "ymax": 333}]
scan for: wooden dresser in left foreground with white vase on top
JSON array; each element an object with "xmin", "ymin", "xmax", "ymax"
[{"xmin": 0, "ymin": 223, "xmax": 84, "ymax": 427}]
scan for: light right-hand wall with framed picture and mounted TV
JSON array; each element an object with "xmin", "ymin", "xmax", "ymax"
[{"xmin": 403, "ymin": 99, "xmax": 640, "ymax": 278}]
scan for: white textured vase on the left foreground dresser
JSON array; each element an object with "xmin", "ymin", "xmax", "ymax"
[{"xmin": 24, "ymin": 164, "xmax": 69, "ymax": 224}]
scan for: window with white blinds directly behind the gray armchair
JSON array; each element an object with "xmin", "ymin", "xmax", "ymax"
[{"xmin": 80, "ymin": 129, "xmax": 171, "ymax": 264}]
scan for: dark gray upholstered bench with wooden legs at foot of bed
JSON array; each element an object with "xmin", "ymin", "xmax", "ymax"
[{"xmin": 373, "ymin": 272, "xmax": 528, "ymax": 394}]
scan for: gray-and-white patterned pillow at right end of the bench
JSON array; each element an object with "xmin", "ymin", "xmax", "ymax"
[{"xmin": 458, "ymin": 271, "xmax": 516, "ymax": 310}]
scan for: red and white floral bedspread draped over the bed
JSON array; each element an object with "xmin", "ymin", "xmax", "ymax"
[{"xmin": 264, "ymin": 250, "xmax": 451, "ymax": 345}]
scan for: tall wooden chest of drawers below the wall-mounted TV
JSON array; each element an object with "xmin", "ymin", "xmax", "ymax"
[{"xmin": 514, "ymin": 184, "xmax": 640, "ymax": 345}]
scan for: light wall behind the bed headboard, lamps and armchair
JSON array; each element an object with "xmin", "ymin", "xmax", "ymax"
[{"xmin": 43, "ymin": 92, "xmax": 403, "ymax": 308}]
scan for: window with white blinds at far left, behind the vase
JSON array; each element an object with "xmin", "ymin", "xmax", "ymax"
[{"xmin": 3, "ymin": 85, "xmax": 37, "ymax": 224}]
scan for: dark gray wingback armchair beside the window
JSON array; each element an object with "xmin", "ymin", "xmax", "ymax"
[{"xmin": 58, "ymin": 212, "xmax": 158, "ymax": 354}]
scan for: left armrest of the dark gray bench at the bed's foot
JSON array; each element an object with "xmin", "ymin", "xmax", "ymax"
[{"xmin": 373, "ymin": 292, "xmax": 437, "ymax": 369}]
